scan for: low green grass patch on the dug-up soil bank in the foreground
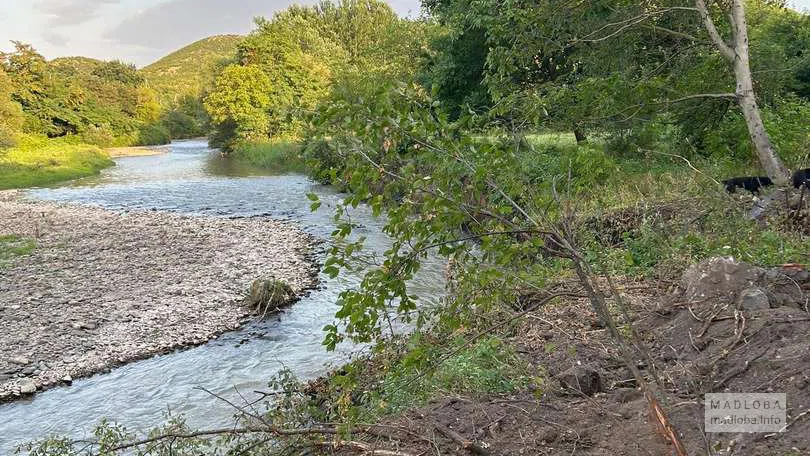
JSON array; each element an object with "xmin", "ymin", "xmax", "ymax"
[{"xmin": 314, "ymin": 334, "xmax": 543, "ymax": 422}]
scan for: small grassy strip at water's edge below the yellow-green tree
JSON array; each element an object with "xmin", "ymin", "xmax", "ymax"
[{"xmin": 230, "ymin": 140, "xmax": 307, "ymax": 174}]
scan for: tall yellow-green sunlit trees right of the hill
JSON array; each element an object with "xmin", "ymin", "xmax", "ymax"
[{"xmin": 206, "ymin": 0, "xmax": 438, "ymax": 151}]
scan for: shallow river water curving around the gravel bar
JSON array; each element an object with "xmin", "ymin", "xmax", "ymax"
[{"xmin": 0, "ymin": 141, "xmax": 444, "ymax": 454}]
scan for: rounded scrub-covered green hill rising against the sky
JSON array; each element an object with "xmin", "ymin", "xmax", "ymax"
[{"xmin": 141, "ymin": 35, "xmax": 242, "ymax": 104}]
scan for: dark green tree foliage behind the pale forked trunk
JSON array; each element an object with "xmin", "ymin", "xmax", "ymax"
[{"xmin": 427, "ymin": 0, "xmax": 810, "ymax": 167}]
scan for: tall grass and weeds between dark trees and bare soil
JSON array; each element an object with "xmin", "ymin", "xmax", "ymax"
[{"xmin": 520, "ymin": 135, "xmax": 810, "ymax": 278}]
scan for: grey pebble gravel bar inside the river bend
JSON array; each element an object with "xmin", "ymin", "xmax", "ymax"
[{"xmin": 0, "ymin": 192, "xmax": 317, "ymax": 402}]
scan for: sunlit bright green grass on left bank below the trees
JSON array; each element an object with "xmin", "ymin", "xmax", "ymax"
[{"xmin": 0, "ymin": 136, "xmax": 115, "ymax": 190}]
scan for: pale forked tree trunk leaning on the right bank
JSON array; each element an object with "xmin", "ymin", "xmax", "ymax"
[{"xmin": 695, "ymin": 0, "xmax": 789, "ymax": 185}]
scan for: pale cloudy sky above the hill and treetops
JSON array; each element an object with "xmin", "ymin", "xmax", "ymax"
[{"xmin": 0, "ymin": 0, "xmax": 810, "ymax": 66}]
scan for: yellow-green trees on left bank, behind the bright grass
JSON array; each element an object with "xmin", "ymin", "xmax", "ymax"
[{"xmin": 0, "ymin": 42, "xmax": 175, "ymax": 146}]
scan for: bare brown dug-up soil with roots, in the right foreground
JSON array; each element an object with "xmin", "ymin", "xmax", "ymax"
[{"xmin": 318, "ymin": 267, "xmax": 810, "ymax": 456}]
